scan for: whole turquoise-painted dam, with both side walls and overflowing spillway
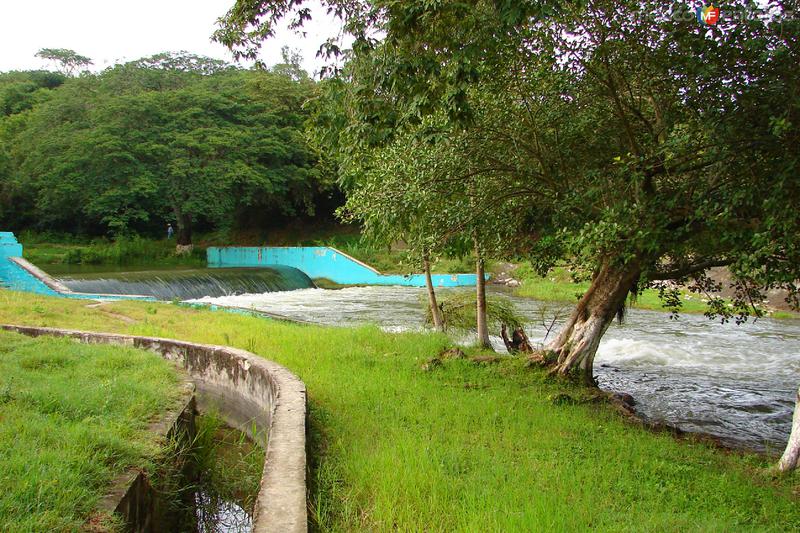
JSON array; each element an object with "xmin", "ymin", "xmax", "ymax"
[{"xmin": 0, "ymin": 232, "xmax": 476, "ymax": 300}]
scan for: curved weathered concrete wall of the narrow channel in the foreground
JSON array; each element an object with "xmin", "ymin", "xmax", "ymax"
[{"xmin": 0, "ymin": 325, "xmax": 308, "ymax": 533}]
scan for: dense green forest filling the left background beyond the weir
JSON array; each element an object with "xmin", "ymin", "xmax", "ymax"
[{"xmin": 0, "ymin": 50, "xmax": 340, "ymax": 245}]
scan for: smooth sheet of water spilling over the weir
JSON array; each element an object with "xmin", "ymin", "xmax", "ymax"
[{"xmin": 54, "ymin": 266, "xmax": 314, "ymax": 300}]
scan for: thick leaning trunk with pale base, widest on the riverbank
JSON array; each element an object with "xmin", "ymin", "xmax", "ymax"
[{"xmin": 547, "ymin": 261, "xmax": 641, "ymax": 385}]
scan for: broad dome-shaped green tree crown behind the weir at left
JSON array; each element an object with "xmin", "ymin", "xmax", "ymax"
[{"xmin": 8, "ymin": 56, "xmax": 317, "ymax": 241}]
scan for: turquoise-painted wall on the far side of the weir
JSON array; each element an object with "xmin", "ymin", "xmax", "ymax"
[{"xmin": 207, "ymin": 246, "xmax": 482, "ymax": 287}]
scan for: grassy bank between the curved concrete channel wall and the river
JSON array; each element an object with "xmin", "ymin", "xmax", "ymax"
[{"xmin": 0, "ymin": 291, "xmax": 800, "ymax": 532}]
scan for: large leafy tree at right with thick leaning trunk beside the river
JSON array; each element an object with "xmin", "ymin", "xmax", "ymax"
[{"xmin": 218, "ymin": 0, "xmax": 800, "ymax": 383}]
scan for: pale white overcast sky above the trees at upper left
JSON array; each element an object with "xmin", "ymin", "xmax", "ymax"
[{"xmin": 0, "ymin": 0, "xmax": 339, "ymax": 73}]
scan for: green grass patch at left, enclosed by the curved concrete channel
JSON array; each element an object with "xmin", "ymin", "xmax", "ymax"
[{"xmin": 0, "ymin": 326, "xmax": 179, "ymax": 532}]
